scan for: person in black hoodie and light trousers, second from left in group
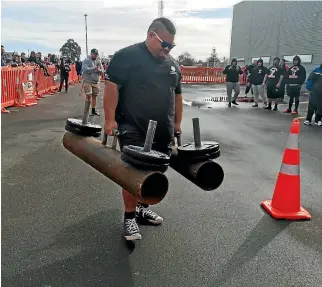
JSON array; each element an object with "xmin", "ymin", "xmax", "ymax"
[{"xmin": 249, "ymin": 59, "xmax": 268, "ymax": 108}]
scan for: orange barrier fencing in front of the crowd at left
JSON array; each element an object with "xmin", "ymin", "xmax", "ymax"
[{"xmin": 1, "ymin": 65, "xmax": 78, "ymax": 113}]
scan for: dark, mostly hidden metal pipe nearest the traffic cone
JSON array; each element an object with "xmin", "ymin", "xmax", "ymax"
[{"xmin": 170, "ymin": 151, "xmax": 224, "ymax": 191}]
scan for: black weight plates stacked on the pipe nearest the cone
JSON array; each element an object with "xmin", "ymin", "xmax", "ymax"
[{"xmin": 178, "ymin": 141, "xmax": 219, "ymax": 157}]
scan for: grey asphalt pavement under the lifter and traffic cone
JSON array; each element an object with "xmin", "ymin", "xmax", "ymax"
[{"xmin": 1, "ymin": 82, "xmax": 322, "ymax": 287}]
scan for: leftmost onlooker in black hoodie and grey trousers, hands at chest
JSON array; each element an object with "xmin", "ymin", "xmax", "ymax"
[{"xmin": 223, "ymin": 58, "xmax": 243, "ymax": 107}]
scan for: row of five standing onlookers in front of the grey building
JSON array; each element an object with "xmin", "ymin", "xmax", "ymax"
[{"xmin": 223, "ymin": 56, "xmax": 322, "ymax": 126}]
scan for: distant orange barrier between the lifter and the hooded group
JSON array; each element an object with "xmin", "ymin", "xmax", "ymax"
[{"xmin": 181, "ymin": 66, "xmax": 247, "ymax": 85}]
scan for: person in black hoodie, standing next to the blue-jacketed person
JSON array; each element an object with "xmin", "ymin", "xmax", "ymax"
[{"xmin": 284, "ymin": 56, "xmax": 306, "ymax": 115}]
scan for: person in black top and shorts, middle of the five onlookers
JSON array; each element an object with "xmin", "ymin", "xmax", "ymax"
[{"xmin": 263, "ymin": 57, "xmax": 284, "ymax": 111}]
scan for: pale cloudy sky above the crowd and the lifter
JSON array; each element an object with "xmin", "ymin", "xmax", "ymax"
[{"xmin": 1, "ymin": 0, "xmax": 240, "ymax": 60}]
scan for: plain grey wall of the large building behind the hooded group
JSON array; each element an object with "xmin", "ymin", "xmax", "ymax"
[{"xmin": 230, "ymin": 1, "xmax": 322, "ymax": 70}]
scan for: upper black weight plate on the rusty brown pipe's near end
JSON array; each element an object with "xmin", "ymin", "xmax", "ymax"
[{"xmin": 122, "ymin": 145, "xmax": 170, "ymax": 165}]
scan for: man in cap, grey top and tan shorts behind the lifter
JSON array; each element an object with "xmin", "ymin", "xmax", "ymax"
[{"xmin": 82, "ymin": 49, "xmax": 104, "ymax": 116}]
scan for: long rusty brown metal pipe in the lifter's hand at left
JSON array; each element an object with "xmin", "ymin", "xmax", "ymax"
[{"xmin": 63, "ymin": 132, "xmax": 169, "ymax": 204}]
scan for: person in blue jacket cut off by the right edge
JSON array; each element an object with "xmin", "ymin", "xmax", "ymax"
[{"xmin": 304, "ymin": 63, "xmax": 322, "ymax": 126}]
